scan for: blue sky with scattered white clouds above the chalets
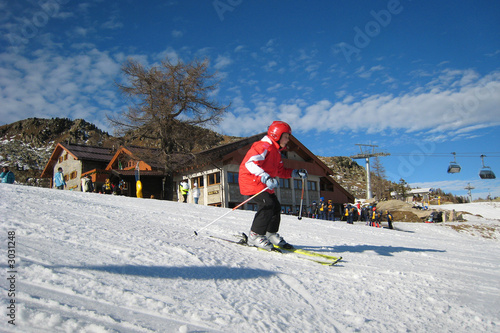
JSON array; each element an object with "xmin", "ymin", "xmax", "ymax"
[{"xmin": 0, "ymin": 0, "xmax": 500, "ymax": 198}]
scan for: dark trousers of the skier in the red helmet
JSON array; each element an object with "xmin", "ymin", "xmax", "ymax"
[{"xmin": 250, "ymin": 191, "xmax": 281, "ymax": 235}]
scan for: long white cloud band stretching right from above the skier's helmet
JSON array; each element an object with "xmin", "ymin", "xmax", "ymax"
[{"xmin": 222, "ymin": 67, "xmax": 500, "ymax": 141}]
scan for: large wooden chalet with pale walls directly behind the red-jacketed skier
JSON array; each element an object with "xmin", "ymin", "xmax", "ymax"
[{"xmin": 174, "ymin": 133, "xmax": 354, "ymax": 212}]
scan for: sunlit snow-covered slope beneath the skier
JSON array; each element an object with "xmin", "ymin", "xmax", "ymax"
[{"xmin": 0, "ymin": 184, "xmax": 500, "ymax": 333}]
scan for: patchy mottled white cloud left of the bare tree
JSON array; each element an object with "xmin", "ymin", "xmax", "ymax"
[{"xmin": 0, "ymin": 49, "xmax": 122, "ymax": 130}]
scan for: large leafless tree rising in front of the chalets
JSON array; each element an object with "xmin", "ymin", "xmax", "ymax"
[{"xmin": 109, "ymin": 59, "xmax": 229, "ymax": 199}]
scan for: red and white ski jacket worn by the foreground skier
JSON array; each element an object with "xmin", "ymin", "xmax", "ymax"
[{"xmin": 239, "ymin": 135, "xmax": 293, "ymax": 195}]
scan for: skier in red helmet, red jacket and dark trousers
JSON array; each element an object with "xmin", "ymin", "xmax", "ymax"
[{"xmin": 239, "ymin": 121, "xmax": 307, "ymax": 251}]
